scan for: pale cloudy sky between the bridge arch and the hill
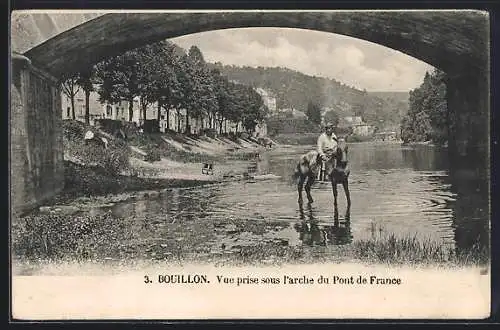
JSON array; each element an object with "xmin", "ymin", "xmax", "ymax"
[{"xmin": 171, "ymin": 28, "xmax": 433, "ymax": 92}]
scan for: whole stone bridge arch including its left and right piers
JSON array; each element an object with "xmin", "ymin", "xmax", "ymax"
[{"xmin": 11, "ymin": 11, "xmax": 489, "ymax": 214}]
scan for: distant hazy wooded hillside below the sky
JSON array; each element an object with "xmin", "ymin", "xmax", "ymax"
[{"xmin": 210, "ymin": 63, "xmax": 408, "ymax": 129}]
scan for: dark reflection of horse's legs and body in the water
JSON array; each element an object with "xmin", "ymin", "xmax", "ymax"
[{"xmin": 294, "ymin": 204, "xmax": 352, "ymax": 246}]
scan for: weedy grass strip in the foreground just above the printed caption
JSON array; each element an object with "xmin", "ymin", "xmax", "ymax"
[{"xmin": 12, "ymin": 213, "xmax": 489, "ymax": 266}]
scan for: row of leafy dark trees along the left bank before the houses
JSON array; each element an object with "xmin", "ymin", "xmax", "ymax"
[{"xmin": 61, "ymin": 41, "xmax": 268, "ymax": 133}]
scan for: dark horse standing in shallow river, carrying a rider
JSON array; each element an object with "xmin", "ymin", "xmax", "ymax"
[{"xmin": 293, "ymin": 139, "xmax": 351, "ymax": 208}]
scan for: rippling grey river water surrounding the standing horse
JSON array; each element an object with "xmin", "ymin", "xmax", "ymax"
[{"xmin": 85, "ymin": 143, "xmax": 489, "ymax": 260}]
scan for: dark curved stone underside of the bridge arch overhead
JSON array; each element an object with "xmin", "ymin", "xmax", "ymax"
[{"xmin": 24, "ymin": 11, "xmax": 489, "ymax": 77}]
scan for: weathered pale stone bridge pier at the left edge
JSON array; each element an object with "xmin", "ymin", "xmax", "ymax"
[{"xmin": 9, "ymin": 53, "xmax": 64, "ymax": 217}]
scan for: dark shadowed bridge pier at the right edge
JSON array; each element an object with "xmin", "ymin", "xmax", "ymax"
[{"xmin": 446, "ymin": 70, "xmax": 490, "ymax": 181}]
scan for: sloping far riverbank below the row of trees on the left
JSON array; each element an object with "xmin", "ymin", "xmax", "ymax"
[{"xmin": 54, "ymin": 120, "xmax": 276, "ymax": 206}]
